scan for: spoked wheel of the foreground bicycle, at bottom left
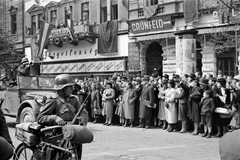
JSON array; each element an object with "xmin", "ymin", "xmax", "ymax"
[{"xmin": 13, "ymin": 143, "xmax": 37, "ymax": 160}]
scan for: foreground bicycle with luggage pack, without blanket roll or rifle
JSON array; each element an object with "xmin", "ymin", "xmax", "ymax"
[{"xmin": 13, "ymin": 123, "xmax": 82, "ymax": 160}]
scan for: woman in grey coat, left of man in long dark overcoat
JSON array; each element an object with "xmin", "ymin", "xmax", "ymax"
[{"xmin": 124, "ymin": 82, "xmax": 137, "ymax": 127}]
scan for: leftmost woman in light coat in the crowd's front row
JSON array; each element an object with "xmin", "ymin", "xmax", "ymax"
[{"xmin": 104, "ymin": 82, "xmax": 115, "ymax": 126}]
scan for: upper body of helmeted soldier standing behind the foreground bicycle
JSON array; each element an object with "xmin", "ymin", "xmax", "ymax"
[{"xmin": 38, "ymin": 74, "xmax": 88, "ymax": 125}]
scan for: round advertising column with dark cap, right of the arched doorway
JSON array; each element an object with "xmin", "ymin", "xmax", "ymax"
[{"xmin": 174, "ymin": 30, "xmax": 197, "ymax": 75}]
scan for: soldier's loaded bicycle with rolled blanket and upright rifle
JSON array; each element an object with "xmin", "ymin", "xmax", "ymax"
[{"xmin": 13, "ymin": 95, "xmax": 93, "ymax": 160}]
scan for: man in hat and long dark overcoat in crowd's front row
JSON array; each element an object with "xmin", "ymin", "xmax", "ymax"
[{"xmin": 139, "ymin": 75, "xmax": 155, "ymax": 129}]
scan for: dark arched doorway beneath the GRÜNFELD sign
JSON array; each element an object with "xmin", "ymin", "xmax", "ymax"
[{"xmin": 146, "ymin": 42, "xmax": 163, "ymax": 76}]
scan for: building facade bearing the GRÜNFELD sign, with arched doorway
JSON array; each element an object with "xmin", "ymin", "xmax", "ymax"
[{"xmin": 129, "ymin": 0, "xmax": 239, "ymax": 75}]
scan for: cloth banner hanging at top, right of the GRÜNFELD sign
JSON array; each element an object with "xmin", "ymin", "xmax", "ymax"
[{"xmin": 183, "ymin": 0, "xmax": 198, "ymax": 23}]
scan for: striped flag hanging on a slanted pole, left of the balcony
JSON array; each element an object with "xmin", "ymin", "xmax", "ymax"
[{"xmin": 38, "ymin": 21, "xmax": 53, "ymax": 58}]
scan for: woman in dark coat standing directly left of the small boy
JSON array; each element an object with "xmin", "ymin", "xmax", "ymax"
[{"xmin": 188, "ymin": 79, "xmax": 202, "ymax": 135}]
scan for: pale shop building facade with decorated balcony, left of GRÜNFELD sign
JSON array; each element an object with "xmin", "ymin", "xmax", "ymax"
[{"xmin": 26, "ymin": 0, "xmax": 128, "ymax": 77}]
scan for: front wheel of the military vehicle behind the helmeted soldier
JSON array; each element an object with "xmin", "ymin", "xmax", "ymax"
[{"xmin": 20, "ymin": 107, "xmax": 36, "ymax": 123}]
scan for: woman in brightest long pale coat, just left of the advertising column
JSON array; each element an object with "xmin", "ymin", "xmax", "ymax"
[{"xmin": 165, "ymin": 80, "xmax": 177, "ymax": 132}]
